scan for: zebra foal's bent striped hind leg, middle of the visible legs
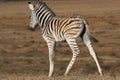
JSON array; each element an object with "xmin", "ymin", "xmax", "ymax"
[{"xmin": 64, "ymin": 39, "xmax": 80, "ymax": 76}]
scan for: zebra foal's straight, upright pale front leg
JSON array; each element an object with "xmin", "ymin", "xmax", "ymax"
[{"xmin": 47, "ymin": 41, "xmax": 55, "ymax": 77}]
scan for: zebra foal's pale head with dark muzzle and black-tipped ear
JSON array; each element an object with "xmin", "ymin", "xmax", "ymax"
[{"xmin": 28, "ymin": 2, "xmax": 38, "ymax": 31}]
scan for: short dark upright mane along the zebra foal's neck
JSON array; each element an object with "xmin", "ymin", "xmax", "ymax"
[{"xmin": 35, "ymin": 1, "xmax": 56, "ymax": 16}]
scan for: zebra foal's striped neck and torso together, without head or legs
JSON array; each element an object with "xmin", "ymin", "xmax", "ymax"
[{"xmin": 32, "ymin": 3, "xmax": 84, "ymax": 42}]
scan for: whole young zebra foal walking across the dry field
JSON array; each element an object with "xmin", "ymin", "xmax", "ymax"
[{"xmin": 28, "ymin": 1, "xmax": 103, "ymax": 77}]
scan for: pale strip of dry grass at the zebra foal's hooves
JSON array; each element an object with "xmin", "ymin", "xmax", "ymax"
[{"xmin": 0, "ymin": 74, "xmax": 120, "ymax": 80}]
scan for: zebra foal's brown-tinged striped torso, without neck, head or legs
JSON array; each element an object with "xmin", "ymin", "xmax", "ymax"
[{"xmin": 42, "ymin": 18, "xmax": 84, "ymax": 42}]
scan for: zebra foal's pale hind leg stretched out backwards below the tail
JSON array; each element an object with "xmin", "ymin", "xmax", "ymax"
[{"xmin": 84, "ymin": 36, "xmax": 103, "ymax": 76}]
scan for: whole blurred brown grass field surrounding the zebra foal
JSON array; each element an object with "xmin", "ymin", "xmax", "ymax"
[{"xmin": 0, "ymin": 0, "xmax": 120, "ymax": 80}]
